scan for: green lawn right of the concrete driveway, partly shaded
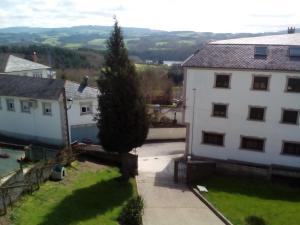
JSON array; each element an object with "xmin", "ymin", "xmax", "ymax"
[{"xmin": 202, "ymin": 176, "xmax": 300, "ymax": 225}]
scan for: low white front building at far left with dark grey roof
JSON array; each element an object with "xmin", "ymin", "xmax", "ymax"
[{"xmin": 0, "ymin": 75, "xmax": 68, "ymax": 146}]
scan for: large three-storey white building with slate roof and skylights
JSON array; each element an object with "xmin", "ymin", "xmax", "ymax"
[{"xmin": 183, "ymin": 34, "xmax": 300, "ymax": 168}]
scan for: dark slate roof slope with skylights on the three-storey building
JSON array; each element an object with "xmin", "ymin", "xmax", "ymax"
[{"xmin": 183, "ymin": 34, "xmax": 300, "ymax": 71}]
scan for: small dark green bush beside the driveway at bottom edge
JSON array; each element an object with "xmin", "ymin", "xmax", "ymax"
[{"xmin": 119, "ymin": 196, "xmax": 144, "ymax": 225}]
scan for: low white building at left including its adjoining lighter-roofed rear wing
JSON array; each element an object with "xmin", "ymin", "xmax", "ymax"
[{"xmin": 0, "ymin": 75, "xmax": 98, "ymax": 146}]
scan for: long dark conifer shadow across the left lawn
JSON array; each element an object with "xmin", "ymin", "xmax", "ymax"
[{"xmin": 39, "ymin": 178, "xmax": 134, "ymax": 225}]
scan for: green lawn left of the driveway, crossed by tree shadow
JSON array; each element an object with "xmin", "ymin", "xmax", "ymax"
[{"xmin": 10, "ymin": 163, "xmax": 136, "ymax": 225}]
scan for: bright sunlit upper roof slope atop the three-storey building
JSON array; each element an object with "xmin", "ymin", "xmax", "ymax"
[{"xmin": 210, "ymin": 33, "xmax": 300, "ymax": 45}]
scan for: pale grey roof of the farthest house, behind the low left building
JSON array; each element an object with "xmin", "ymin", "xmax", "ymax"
[{"xmin": 4, "ymin": 55, "xmax": 50, "ymax": 73}]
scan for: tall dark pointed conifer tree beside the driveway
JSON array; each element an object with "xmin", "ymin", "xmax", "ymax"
[{"xmin": 98, "ymin": 19, "xmax": 148, "ymax": 178}]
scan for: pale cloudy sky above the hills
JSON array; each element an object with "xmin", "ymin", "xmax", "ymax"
[{"xmin": 0, "ymin": 0, "xmax": 300, "ymax": 33}]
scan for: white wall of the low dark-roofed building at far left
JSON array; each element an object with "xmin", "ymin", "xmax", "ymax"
[{"xmin": 0, "ymin": 96, "xmax": 64, "ymax": 145}]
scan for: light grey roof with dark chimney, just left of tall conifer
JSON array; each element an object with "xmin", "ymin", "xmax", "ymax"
[{"xmin": 65, "ymin": 80, "xmax": 98, "ymax": 100}]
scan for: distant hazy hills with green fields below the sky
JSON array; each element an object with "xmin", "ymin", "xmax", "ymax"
[{"xmin": 0, "ymin": 26, "xmax": 298, "ymax": 61}]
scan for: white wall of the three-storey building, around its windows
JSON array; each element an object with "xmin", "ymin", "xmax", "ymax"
[{"xmin": 185, "ymin": 68, "xmax": 300, "ymax": 167}]
